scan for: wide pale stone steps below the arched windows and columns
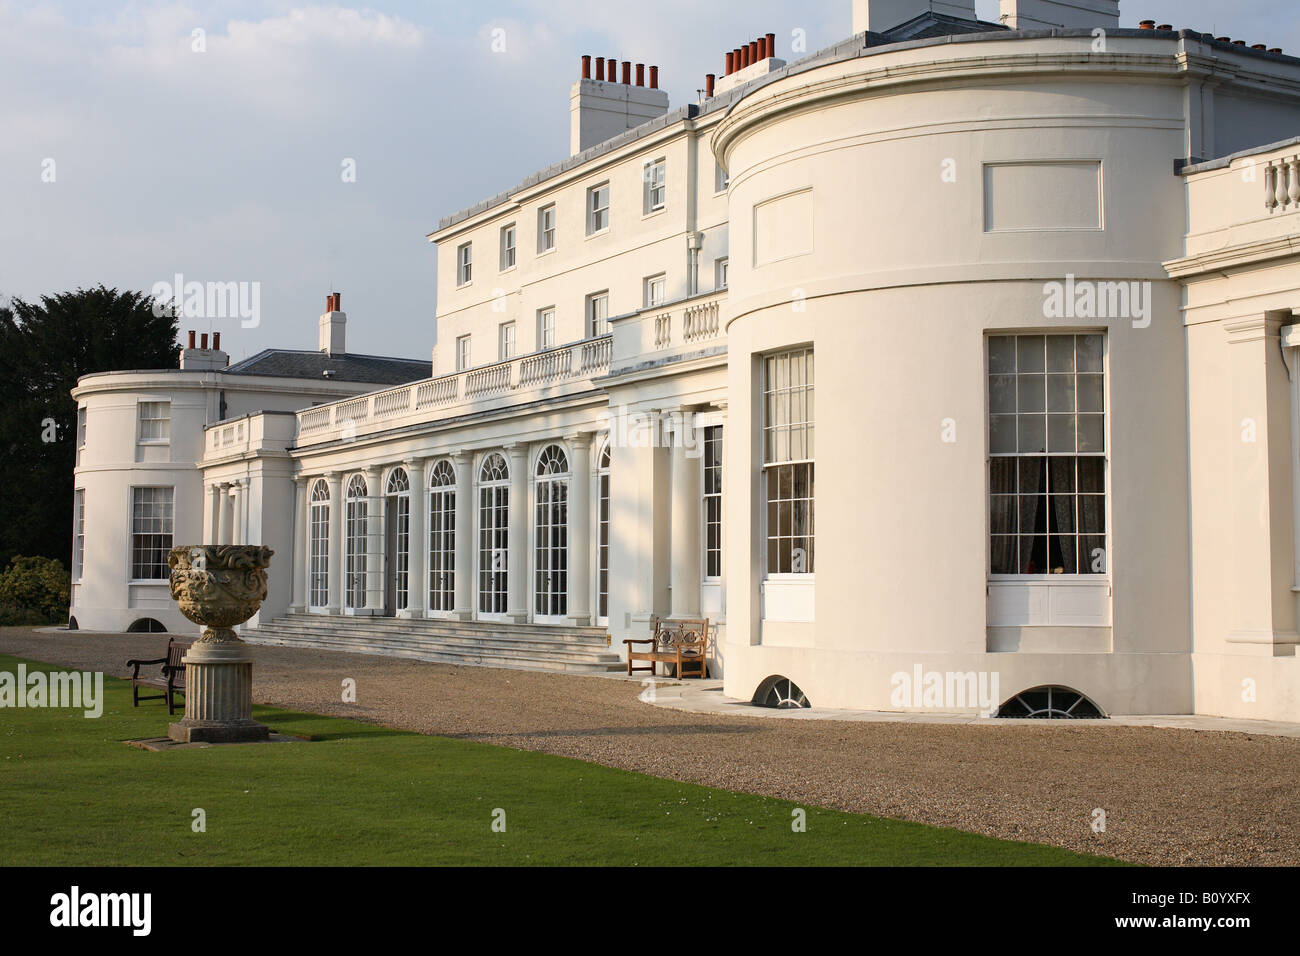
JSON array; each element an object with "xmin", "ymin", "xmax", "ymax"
[{"xmin": 241, "ymin": 614, "xmax": 624, "ymax": 674}]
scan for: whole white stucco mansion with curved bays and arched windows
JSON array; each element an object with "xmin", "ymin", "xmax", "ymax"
[{"xmin": 72, "ymin": 0, "xmax": 1300, "ymax": 721}]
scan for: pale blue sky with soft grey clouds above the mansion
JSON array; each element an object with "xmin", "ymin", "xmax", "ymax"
[{"xmin": 0, "ymin": 0, "xmax": 1300, "ymax": 360}]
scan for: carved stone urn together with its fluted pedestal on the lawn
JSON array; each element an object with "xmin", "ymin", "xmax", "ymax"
[{"xmin": 166, "ymin": 545, "xmax": 274, "ymax": 743}]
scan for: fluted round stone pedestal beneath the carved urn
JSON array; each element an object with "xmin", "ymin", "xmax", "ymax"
[{"xmin": 168, "ymin": 639, "xmax": 270, "ymax": 744}]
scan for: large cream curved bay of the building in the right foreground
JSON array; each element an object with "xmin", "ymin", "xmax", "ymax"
[{"xmin": 714, "ymin": 27, "xmax": 1192, "ymax": 713}]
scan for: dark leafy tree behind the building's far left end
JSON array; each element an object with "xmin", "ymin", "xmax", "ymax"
[{"xmin": 0, "ymin": 285, "xmax": 181, "ymax": 566}]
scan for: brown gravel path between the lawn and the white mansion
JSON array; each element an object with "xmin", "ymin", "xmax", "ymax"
[{"xmin": 0, "ymin": 628, "xmax": 1300, "ymax": 866}]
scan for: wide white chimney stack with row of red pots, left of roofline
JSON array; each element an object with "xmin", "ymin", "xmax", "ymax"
[{"xmin": 569, "ymin": 56, "xmax": 668, "ymax": 156}]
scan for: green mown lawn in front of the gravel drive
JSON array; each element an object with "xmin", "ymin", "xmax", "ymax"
[{"xmin": 0, "ymin": 656, "xmax": 1115, "ymax": 866}]
